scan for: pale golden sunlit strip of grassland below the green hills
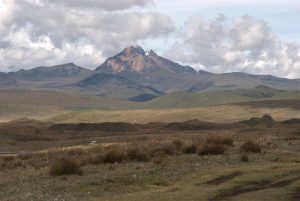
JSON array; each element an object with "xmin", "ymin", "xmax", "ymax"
[{"xmin": 47, "ymin": 101, "xmax": 300, "ymax": 123}]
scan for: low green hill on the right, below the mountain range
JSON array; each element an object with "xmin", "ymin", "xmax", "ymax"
[{"xmin": 143, "ymin": 85, "xmax": 300, "ymax": 108}]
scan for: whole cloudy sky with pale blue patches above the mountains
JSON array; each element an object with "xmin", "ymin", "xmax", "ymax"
[{"xmin": 0, "ymin": 0, "xmax": 300, "ymax": 78}]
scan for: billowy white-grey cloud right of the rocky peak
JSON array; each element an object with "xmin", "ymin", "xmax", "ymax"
[{"xmin": 166, "ymin": 14, "xmax": 300, "ymax": 78}]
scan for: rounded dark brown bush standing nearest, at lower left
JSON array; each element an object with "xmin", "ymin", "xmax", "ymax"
[{"xmin": 49, "ymin": 156, "xmax": 82, "ymax": 176}]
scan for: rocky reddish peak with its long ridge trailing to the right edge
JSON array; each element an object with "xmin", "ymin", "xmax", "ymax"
[{"xmin": 95, "ymin": 46, "xmax": 300, "ymax": 93}]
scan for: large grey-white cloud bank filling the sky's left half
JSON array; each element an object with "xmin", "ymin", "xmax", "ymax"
[{"xmin": 0, "ymin": 0, "xmax": 175, "ymax": 71}]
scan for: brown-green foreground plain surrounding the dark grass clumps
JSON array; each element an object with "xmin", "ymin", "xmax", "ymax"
[{"xmin": 0, "ymin": 116, "xmax": 300, "ymax": 201}]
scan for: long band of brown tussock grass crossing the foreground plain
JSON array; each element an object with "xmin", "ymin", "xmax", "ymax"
[{"xmin": 0, "ymin": 137, "xmax": 233, "ymax": 176}]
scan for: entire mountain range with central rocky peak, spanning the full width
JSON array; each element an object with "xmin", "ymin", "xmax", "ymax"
[{"xmin": 0, "ymin": 46, "xmax": 300, "ymax": 102}]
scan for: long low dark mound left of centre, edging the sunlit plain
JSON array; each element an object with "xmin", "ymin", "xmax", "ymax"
[{"xmin": 48, "ymin": 122, "xmax": 138, "ymax": 132}]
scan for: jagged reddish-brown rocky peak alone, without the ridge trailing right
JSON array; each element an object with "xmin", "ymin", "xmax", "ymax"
[{"xmin": 95, "ymin": 46, "xmax": 207, "ymax": 92}]
